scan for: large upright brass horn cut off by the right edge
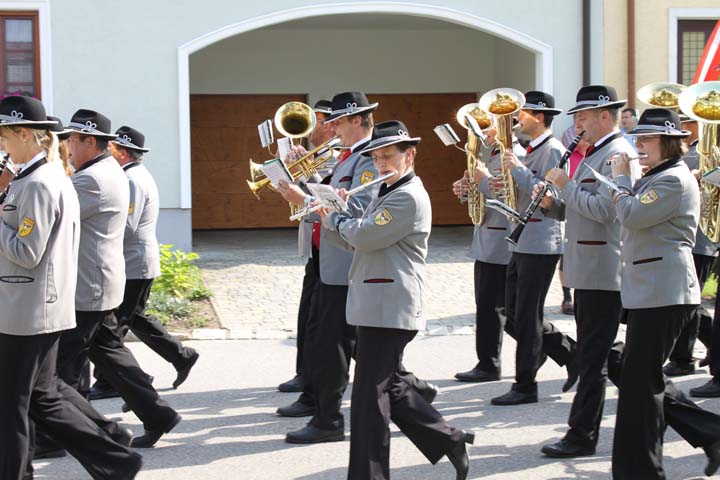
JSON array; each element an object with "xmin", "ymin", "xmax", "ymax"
[{"xmin": 680, "ymin": 82, "xmax": 720, "ymax": 242}]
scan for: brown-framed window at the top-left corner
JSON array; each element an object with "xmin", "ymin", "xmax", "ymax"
[{"xmin": 0, "ymin": 11, "xmax": 41, "ymax": 98}]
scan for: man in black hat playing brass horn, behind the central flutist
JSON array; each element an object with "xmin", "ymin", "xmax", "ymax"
[{"xmin": 278, "ymin": 92, "xmax": 378, "ymax": 443}]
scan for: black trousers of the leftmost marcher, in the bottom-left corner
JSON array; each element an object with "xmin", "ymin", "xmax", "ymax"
[{"xmin": 0, "ymin": 333, "xmax": 140, "ymax": 480}]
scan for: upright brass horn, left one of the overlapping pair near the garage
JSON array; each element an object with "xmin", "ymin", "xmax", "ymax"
[{"xmin": 455, "ymin": 103, "xmax": 493, "ymax": 225}]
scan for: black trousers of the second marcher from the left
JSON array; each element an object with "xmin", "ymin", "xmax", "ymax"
[{"xmin": 55, "ymin": 310, "xmax": 177, "ymax": 433}]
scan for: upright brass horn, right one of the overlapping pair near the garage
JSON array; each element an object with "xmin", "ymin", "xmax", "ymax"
[{"xmin": 478, "ymin": 88, "xmax": 525, "ymax": 219}]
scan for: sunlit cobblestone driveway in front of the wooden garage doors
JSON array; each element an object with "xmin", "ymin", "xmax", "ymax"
[{"xmin": 193, "ymin": 227, "xmax": 575, "ymax": 339}]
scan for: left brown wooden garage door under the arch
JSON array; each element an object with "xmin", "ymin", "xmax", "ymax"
[{"xmin": 190, "ymin": 95, "xmax": 306, "ymax": 229}]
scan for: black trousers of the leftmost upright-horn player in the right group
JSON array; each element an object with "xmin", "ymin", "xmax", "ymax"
[{"xmin": 475, "ymin": 261, "xmax": 575, "ymax": 375}]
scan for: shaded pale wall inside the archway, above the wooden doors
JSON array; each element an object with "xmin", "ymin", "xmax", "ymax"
[{"xmin": 190, "ymin": 22, "xmax": 535, "ymax": 99}]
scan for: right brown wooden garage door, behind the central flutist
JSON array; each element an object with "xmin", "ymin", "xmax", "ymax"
[{"xmin": 368, "ymin": 93, "xmax": 477, "ymax": 225}]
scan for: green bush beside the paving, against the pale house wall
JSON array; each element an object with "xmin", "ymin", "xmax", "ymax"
[{"xmin": 147, "ymin": 245, "xmax": 212, "ymax": 326}]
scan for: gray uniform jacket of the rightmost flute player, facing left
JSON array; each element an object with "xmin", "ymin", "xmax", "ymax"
[{"xmin": 616, "ymin": 159, "xmax": 700, "ymax": 309}]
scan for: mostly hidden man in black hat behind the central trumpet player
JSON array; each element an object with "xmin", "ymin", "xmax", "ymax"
[{"xmin": 277, "ymin": 100, "xmax": 337, "ymax": 398}]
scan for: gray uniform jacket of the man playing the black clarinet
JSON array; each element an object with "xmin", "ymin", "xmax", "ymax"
[{"xmin": 547, "ymin": 132, "xmax": 634, "ymax": 292}]
